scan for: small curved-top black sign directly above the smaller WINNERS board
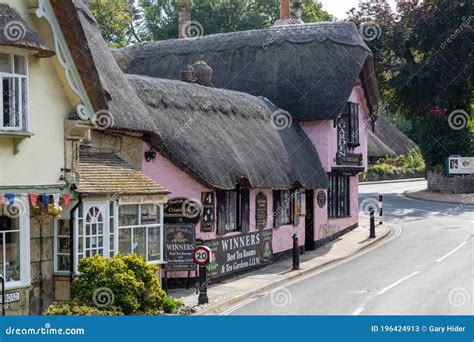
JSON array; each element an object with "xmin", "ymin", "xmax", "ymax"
[{"xmin": 163, "ymin": 197, "xmax": 201, "ymax": 223}]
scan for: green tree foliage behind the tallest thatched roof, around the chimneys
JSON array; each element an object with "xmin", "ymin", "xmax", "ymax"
[{"xmin": 93, "ymin": 0, "xmax": 333, "ymax": 47}]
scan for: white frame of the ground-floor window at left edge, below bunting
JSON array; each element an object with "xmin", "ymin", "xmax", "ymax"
[{"xmin": 0, "ymin": 195, "xmax": 31, "ymax": 290}]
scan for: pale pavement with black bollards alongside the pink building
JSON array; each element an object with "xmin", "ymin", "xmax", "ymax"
[{"xmin": 169, "ymin": 216, "xmax": 393, "ymax": 315}]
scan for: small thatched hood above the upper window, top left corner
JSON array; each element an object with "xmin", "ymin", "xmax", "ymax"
[{"xmin": 0, "ymin": 4, "xmax": 55, "ymax": 58}]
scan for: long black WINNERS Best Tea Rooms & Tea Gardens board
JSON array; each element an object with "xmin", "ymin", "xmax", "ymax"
[{"xmin": 204, "ymin": 229, "xmax": 273, "ymax": 278}]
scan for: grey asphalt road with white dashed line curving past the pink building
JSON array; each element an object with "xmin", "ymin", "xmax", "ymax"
[{"xmin": 225, "ymin": 182, "xmax": 474, "ymax": 315}]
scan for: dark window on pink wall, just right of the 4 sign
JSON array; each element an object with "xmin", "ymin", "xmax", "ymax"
[{"xmin": 217, "ymin": 191, "xmax": 239, "ymax": 235}]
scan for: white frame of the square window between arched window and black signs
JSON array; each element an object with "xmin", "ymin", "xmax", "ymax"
[{"xmin": 115, "ymin": 203, "xmax": 164, "ymax": 265}]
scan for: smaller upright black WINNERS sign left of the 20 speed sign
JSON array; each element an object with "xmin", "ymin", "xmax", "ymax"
[{"xmin": 165, "ymin": 224, "xmax": 196, "ymax": 271}]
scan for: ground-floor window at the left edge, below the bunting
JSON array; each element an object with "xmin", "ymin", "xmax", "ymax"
[{"xmin": 0, "ymin": 198, "xmax": 30, "ymax": 286}]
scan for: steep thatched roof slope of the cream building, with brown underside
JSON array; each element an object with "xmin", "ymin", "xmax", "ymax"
[{"xmin": 52, "ymin": 0, "xmax": 153, "ymax": 131}]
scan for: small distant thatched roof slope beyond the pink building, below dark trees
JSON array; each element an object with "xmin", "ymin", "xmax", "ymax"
[{"xmin": 369, "ymin": 117, "xmax": 416, "ymax": 156}]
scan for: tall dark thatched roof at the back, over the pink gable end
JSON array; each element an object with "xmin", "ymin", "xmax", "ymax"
[{"xmin": 114, "ymin": 22, "xmax": 378, "ymax": 120}]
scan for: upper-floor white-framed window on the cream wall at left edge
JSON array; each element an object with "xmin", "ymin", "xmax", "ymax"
[{"xmin": 0, "ymin": 53, "xmax": 28, "ymax": 131}]
